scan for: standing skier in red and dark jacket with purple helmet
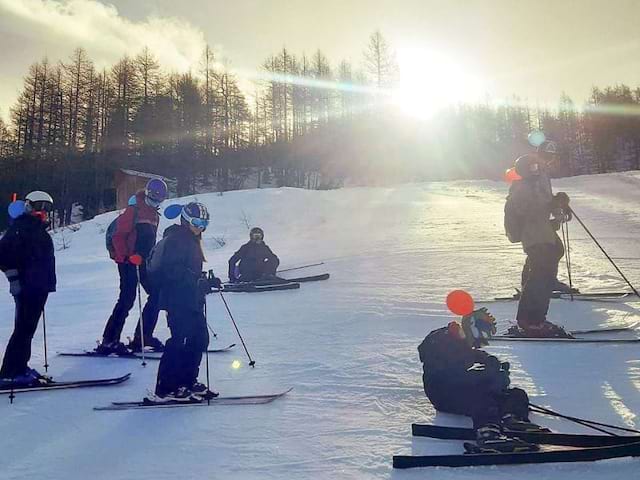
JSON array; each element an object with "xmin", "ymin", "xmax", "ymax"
[{"xmin": 96, "ymin": 179, "xmax": 167, "ymax": 355}]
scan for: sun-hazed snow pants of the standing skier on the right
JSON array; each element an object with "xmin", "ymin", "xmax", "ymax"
[{"xmin": 516, "ymin": 240, "xmax": 564, "ymax": 328}]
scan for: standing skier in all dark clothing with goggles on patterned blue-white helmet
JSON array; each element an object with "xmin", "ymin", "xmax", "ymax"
[{"xmin": 149, "ymin": 202, "xmax": 221, "ymax": 401}]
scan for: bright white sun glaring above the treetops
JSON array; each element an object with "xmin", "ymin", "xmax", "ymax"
[{"xmin": 393, "ymin": 48, "xmax": 483, "ymax": 119}]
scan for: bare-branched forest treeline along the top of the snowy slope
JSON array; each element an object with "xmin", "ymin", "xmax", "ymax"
[{"xmin": 0, "ymin": 31, "xmax": 640, "ymax": 228}]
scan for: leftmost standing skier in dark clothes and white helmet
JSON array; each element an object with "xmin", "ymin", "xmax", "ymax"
[{"xmin": 0, "ymin": 191, "xmax": 56, "ymax": 385}]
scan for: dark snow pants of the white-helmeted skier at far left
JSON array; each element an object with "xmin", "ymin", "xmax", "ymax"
[{"xmin": 0, "ymin": 292, "xmax": 49, "ymax": 378}]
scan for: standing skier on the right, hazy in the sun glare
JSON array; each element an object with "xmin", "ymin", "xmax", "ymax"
[{"xmin": 505, "ymin": 154, "xmax": 571, "ymax": 337}]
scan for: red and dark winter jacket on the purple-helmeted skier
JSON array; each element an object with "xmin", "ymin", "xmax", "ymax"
[{"xmin": 112, "ymin": 191, "xmax": 160, "ymax": 263}]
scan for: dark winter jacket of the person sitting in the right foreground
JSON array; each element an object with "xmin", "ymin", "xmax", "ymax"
[{"xmin": 418, "ymin": 327, "xmax": 509, "ymax": 398}]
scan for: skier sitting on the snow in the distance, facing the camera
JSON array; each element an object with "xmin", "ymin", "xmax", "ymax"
[{"xmin": 229, "ymin": 227, "xmax": 280, "ymax": 283}]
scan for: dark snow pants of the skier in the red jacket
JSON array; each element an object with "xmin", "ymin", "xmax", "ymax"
[{"xmin": 102, "ymin": 263, "xmax": 159, "ymax": 343}]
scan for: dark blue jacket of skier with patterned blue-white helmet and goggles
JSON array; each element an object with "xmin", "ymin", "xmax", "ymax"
[{"xmin": 152, "ymin": 225, "xmax": 204, "ymax": 312}]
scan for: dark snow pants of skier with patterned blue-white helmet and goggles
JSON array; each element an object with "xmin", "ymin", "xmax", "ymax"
[{"xmin": 156, "ymin": 310, "xmax": 209, "ymax": 396}]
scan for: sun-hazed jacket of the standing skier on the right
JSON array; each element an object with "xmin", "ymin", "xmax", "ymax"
[{"xmin": 509, "ymin": 173, "xmax": 559, "ymax": 252}]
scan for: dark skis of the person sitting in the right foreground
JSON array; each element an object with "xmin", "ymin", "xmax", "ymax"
[{"xmin": 393, "ymin": 424, "xmax": 640, "ymax": 468}]
